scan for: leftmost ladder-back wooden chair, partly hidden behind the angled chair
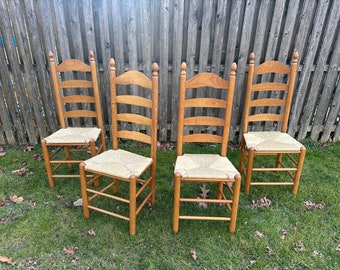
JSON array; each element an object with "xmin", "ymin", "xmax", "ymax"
[{"xmin": 41, "ymin": 51, "xmax": 105, "ymax": 188}]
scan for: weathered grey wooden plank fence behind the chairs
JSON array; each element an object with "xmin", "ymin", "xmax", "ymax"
[{"xmin": 0, "ymin": 0, "xmax": 340, "ymax": 144}]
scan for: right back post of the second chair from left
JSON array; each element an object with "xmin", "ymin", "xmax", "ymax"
[{"xmin": 151, "ymin": 63, "xmax": 159, "ymax": 162}]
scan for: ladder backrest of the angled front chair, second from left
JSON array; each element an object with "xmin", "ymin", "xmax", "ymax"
[{"xmin": 110, "ymin": 59, "xmax": 158, "ymax": 158}]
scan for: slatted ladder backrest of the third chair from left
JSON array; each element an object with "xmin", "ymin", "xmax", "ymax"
[{"xmin": 177, "ymin": 62, "xmax": 237, "ymax": 156}]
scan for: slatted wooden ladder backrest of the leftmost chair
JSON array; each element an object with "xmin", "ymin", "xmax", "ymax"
[{"xmin": 49, "ymin": 51, "xmax": 104, "ymax": 130}]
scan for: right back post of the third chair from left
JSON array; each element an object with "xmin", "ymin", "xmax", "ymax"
[{"xmin": 221, "ymin": 63, "xmax": 237, "ymax": 157}]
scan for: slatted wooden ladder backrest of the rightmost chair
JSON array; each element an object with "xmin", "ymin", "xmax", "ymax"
[{"xmin": 243, "ymin": 52, "xmax": 298, "ymax": 133}]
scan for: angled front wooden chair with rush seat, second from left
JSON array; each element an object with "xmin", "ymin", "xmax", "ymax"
[{"xmin": 79, "ymin": 59, "xmax": 158, "ymax": 235}]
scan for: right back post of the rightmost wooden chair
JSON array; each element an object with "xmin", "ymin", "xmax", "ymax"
[{"xmin": 281, "ymin": 51, "xmax": 299, "ymax": 132}]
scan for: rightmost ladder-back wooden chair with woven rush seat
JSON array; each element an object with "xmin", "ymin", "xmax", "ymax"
[{"xmin": 239, "ymin": 52, "xmax": 306, "ymax": 194}]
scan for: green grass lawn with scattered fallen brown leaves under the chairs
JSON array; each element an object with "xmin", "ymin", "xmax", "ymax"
[{"xmin": 0, "ymin": 141, "xmax": 340, "ymax": 269}]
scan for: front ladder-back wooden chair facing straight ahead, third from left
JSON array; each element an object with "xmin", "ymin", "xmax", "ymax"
[{"xmin": 173, "ymin": 63, "xmax": 241, "ymax": 233}]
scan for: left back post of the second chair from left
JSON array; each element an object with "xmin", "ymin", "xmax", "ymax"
[{"xmin": 110, "ymin": 58, "xmax": 118, "ymax": 150}]
